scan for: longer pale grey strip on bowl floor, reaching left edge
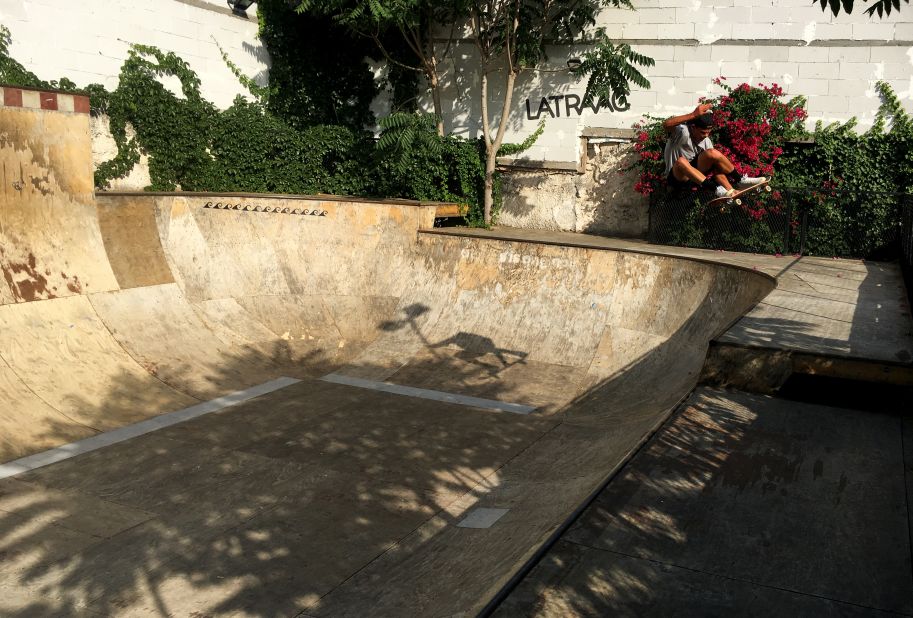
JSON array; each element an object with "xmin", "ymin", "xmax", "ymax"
[{"xmin": 0, "ymin": 378, "xmax": 300, "ymax": 479}]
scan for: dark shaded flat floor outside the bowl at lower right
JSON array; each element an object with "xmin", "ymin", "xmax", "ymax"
[{"xmin": 496, "ymin": 388, "xmax": 913, "ymax": 616}]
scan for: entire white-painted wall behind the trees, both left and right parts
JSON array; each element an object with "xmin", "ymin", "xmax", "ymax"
[{"xmin": 0, "ymin": 0, "xmax": 913, "ymax": 168}]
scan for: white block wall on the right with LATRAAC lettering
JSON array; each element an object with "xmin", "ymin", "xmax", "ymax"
[{"xmin": 429, "ymin": 0, "xmax": 913, "ymax": 161}]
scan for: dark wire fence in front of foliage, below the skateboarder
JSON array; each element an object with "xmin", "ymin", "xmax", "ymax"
[{"xmin": 648, "ymin": 187, "xmax": 913, "ymax": 259}]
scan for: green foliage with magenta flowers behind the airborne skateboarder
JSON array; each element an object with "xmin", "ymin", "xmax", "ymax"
[{"xmin": 635, "ymin": 82, "xmax": 913, "ymax": 257}]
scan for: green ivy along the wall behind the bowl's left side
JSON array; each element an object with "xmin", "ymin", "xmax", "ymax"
[{"xmin": 0, "ymin": 25, "xmax": 492, "ymax": 212}]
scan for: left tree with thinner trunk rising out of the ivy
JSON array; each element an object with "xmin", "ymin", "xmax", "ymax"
[{"xmin": 295, "ymin": 0, "xmax": 465, "ymax": 137}]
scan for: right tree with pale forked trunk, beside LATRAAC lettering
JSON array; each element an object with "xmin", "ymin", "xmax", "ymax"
[{"xmin": 468, "ymin": 0, "xmax": 654, "ymax": 224}]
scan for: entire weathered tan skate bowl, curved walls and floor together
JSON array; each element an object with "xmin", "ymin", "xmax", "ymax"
[{"xmin": 0, "ymin": 84, "xmax": 774, "ymax": 616}]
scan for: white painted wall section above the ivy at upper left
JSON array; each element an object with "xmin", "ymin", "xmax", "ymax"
[{"xmin": 0, "ymin": 0, "xmax": 269, "ymax": 108}]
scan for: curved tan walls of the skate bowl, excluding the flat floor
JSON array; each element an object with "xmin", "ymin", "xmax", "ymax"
[{"xmin": 0, "ymin": 88, "xmax": 775, "ymax": 615}]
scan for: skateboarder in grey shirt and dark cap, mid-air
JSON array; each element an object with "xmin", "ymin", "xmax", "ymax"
[{"xmin": 663, "ymin": 103, "xmax": 767, "ymax": 198}]
